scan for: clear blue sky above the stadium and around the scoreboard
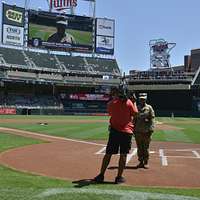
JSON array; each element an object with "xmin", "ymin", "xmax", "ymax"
[{"xmin": 0, "ymin": 0, "xmax": 200, "ymax": 74}]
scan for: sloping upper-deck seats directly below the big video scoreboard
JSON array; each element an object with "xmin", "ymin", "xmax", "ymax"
[{"xmin": 0, "ymin": 47, "xmax": 120, "ymax": 81}]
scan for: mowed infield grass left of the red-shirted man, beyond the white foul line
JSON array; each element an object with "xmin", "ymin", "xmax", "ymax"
[{"xmin": 0, "ymin": 116, "xmax": 108, "ymax": 140}]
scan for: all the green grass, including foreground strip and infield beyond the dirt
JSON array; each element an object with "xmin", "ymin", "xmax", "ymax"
[{"xmin": 0, "ymin": 116, "xmax": 200, "ymax": 200}]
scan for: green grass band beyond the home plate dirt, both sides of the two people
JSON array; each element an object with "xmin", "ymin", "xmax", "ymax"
[{"xmin": 0, "ymin": 116, "xmax": 200, "ymax": 144}]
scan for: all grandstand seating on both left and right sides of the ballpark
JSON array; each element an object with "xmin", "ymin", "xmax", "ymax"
[{"xmin": 0, "ymin": 46, "xmax": 200, "ymax": 116}]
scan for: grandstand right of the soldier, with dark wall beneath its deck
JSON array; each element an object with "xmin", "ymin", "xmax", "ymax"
[{"xmin": 126, "ymin": 47, "xmax": 200, "ymax": 116}]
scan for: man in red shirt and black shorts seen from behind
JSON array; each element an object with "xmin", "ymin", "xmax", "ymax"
[{"xmin": 94, "ymin": 87, "xmax": 138, "ymax": 184}]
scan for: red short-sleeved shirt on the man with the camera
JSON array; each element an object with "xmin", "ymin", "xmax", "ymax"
[{"xmin": 107, "ymin": 98, "xmax": 138, "ymax": 134}]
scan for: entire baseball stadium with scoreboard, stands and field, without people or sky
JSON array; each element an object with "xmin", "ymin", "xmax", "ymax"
[{"xmin": 0, "ymin": 0, "xmax": 200, "ymax": 200}]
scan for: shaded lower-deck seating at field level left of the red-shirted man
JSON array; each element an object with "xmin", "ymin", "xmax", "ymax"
[{"xmin": 0, "ymin": 91, "xmax": 107, "ymax": 114}]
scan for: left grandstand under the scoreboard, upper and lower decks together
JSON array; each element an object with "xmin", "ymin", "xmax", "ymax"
[{"xmin": 0, "ymin": 46, "xmax": 121, "ymax": 114}]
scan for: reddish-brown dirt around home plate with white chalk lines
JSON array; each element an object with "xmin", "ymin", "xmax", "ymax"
[{"xmin": 0, "ymin": 128, "xmax": 200, "ymax": 188}]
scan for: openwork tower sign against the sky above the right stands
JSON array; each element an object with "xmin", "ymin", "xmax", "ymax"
[{"xmin": 149, "ymin": 39, "xmax": 176, "ymax": 69}]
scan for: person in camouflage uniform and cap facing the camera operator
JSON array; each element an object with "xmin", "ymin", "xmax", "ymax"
[{"xmin": 134, "ymin": 93, "xmax": 155, "ymax": 168}]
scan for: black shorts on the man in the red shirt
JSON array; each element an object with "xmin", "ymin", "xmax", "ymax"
[{"xmin": 106, "ymin": 128, "xmax": 132, "ymax": 154}]
